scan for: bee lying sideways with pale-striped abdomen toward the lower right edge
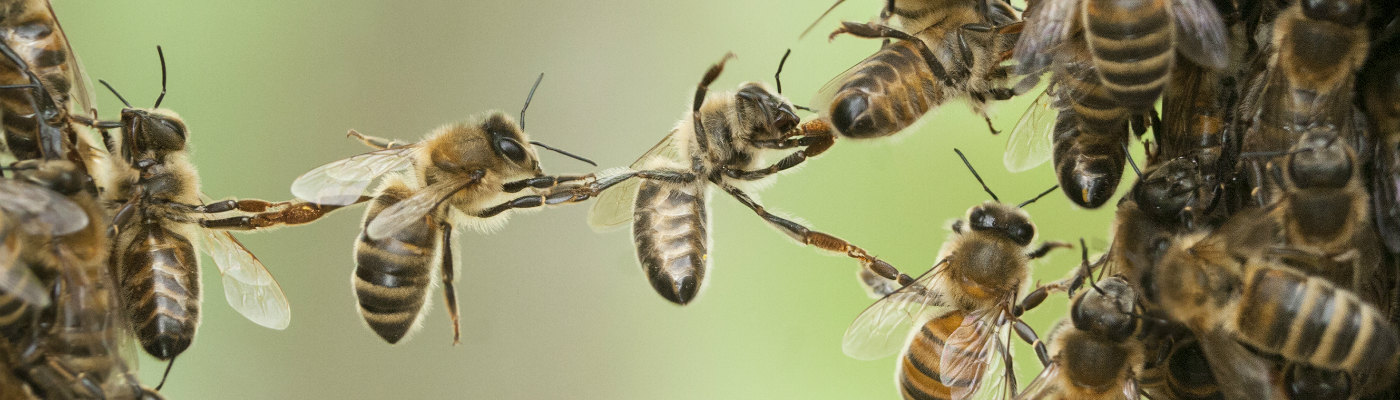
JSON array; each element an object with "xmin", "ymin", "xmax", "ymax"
[{"xmin": 1155, "ymin": 227, "xmax": 1400, "ymax": 393}]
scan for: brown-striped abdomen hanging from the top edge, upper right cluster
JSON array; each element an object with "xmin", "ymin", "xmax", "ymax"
[{"xmin": 1081, "ymin": 0, "xmax": 1176, "ymax": 110}]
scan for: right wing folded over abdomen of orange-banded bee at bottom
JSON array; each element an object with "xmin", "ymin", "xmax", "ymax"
[{"xmin": 938, "ymin": 310, "xmax": 1011, "ymax": 399}]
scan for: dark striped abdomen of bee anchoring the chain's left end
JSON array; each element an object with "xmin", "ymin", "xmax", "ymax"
[{"xmin": 118, "ymin": 224, "xmax": 200, "ymax": 359}]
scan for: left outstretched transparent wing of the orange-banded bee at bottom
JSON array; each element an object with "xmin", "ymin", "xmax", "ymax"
[{"xmin": 841, "ymin": 262, "xmax": 951, "ymax": 359}]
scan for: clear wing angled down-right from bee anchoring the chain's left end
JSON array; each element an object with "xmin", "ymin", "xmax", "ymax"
[{"xmin": 202, "ymin": 229, "xmax": 291, "ymax": 330}]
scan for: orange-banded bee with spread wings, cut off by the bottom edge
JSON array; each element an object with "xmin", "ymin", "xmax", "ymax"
[{"xmin": 841, "ymin": 151, "xmax": 1068, "ymax": 399}]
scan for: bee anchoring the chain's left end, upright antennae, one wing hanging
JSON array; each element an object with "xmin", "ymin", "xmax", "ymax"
[{"xmin": 98, "ymin": 48, "xmax": 291, "ymax": 369}]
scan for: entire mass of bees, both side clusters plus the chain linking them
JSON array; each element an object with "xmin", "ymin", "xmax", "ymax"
[{"xmin": 0, "ymin": 0, "xmax": 1400, "ymax": 399}]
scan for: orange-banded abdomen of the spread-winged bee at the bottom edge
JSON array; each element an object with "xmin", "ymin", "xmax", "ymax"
[{"xmin": 895, "ymin": 310, "xmax": 981, "ymax": 400}]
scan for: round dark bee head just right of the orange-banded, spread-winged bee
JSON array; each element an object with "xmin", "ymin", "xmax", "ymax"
[{"xmin": 1070, "ymin": 277, "xmax": 1135, "ymax": 341}]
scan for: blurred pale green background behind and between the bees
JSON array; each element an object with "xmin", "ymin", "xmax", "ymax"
[{"xmin": 55, "ymin": 0, "xmax": 1112, "ymax": 399}]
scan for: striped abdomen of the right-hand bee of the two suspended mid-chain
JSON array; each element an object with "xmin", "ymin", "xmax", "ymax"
[{"xmin": 631, "ymin": 180, "xmax": 710, "ymax": 305}]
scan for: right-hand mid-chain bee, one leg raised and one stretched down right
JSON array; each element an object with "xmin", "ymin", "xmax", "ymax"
[{"xmin": 588, "ymin": 55, "xmax": 911, "ymax": 305}]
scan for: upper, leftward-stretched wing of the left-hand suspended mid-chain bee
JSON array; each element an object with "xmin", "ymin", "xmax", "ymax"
[{"xmin": 291, "ymin": 144, "xmax": 419, "ymax": 206}]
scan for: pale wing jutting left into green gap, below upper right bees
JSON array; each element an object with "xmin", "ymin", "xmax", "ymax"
[{"xmin": 1001, "ymin": 90, "xmax": 1060, "ymax": 172}]
